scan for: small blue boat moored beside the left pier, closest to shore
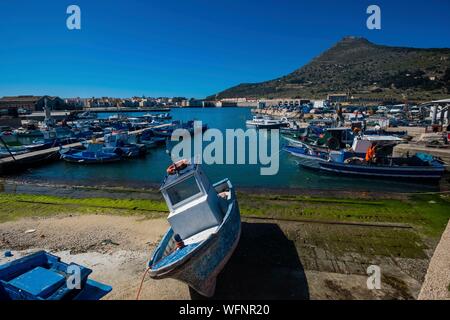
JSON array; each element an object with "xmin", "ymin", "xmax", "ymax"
[{"xmin": 60, "ymin": 143, "xmax": 122, "ymax": 164}]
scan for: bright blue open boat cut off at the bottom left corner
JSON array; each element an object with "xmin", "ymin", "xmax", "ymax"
[{"xmin": 0, "ymin": 251, "xmax": 112, "ymax": 300}]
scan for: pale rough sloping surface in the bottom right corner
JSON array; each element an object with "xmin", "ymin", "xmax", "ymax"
[{"xmin": 419, "ymin": 222, "xmax": 450, "ymax": 300}]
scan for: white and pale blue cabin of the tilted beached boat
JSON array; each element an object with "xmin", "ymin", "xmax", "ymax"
[{"xmin": 160, "ymin": 164, "xmax": 223, "ymax": 243}]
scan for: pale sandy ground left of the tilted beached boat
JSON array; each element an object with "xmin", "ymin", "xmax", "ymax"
[{"xmin": 0, "ymin": 215, "xmax": 189, "ymax": 299}]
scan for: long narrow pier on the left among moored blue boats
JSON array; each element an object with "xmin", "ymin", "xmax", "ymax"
[{"xmin": 0, "ymin": 124, "xmax": 170, "ymax": 175}]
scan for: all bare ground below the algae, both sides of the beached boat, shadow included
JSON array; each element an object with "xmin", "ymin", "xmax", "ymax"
[{"xmin": 0, "ymin": 215, "xmax": 429, "ymax": 299}]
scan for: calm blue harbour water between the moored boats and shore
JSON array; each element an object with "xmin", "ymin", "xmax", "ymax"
[{"xmin": 13, "ymin": 108, "xmax": 437, "ymax": 192}]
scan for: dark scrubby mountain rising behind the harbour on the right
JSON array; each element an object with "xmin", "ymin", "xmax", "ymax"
[{"xmin": 213, "ymin": 37, "xmax": 450, "ymax": 100}]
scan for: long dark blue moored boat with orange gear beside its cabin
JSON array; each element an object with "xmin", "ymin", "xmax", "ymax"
[{"xmin": 284, "ymin": 136, "xmax": 445, "ymax": 181}]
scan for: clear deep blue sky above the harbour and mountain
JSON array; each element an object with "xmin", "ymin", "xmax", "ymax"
[{"xmin": 0, "ymin": 0, "xmax": 450, "ymax": 98}]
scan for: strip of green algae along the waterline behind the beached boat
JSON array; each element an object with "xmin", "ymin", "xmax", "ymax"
[{"xmin": 0, "ymin": 193, "xmax": 450, "ymax": 237}]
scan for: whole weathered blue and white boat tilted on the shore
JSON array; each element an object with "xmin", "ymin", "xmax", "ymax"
[{"xmin": 148, "ymin": 160, "xmax": 241, "ymax": 297}]
